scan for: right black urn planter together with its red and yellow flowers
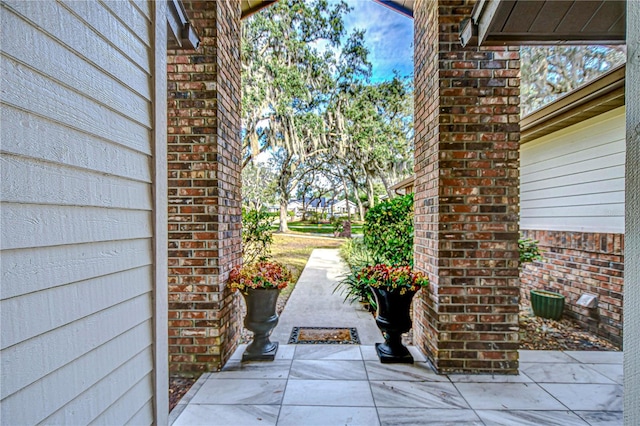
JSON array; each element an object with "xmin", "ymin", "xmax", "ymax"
[{"xmin": 357, "ymin": 264, "xmax": 429, "ymax": 363}]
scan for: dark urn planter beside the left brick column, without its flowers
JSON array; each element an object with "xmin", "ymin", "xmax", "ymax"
[{"xmin": 242, "ymin": 288, "xmax": 280, "ymax": 361}]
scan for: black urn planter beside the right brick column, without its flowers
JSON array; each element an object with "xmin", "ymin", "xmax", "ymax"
[{"xmin": 371, "ymin": 287, "xmax": 416, "ymax": 364}]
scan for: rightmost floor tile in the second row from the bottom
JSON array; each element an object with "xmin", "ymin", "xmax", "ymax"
[{"xmin": 540, "ymin": 383, "xmax": 623, "ymax": 411}]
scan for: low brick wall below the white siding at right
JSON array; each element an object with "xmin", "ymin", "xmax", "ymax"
[{"xmin": 520, "ymin": 230, "xmax": 624, "ymax": 346}]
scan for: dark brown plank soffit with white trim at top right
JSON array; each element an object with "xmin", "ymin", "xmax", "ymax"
[{"xmin": 460, "ymin": 0, "xmax": 626, "ymax": 46}]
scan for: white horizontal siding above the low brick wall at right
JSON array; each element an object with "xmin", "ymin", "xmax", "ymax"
[{"xmin": 520, "ymin": 107, "xmax": 625, "ymax": 233}]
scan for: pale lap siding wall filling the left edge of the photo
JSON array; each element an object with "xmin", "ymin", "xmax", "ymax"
[{"xmin": 0, "ymin": 1, "xmax": 160, "ymax": 425}]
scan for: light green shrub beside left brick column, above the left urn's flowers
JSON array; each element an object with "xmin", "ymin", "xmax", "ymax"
[{"xmin": 242, "ymin": 209, "xmax": 273, "ymax": 264}]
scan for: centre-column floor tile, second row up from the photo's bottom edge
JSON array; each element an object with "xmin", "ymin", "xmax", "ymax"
[{"xmin": 282, "ymin": 380, "xmax": 374, "ymax": 407}]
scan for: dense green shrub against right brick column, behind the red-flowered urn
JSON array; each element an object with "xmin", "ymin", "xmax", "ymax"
[{"xmin": 364, "ymin": 194, "xmax": 413, "ymax": 265}]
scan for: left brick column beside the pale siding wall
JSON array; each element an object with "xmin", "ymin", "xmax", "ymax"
[{"xmin": 168, "ymin": 0, "xmax": 242, "ymax": 375}]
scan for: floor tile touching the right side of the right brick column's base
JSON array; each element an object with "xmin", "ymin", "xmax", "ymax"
[{"xmin": 520, "ymin": 363, "xmax": 614, "ymax": 384}]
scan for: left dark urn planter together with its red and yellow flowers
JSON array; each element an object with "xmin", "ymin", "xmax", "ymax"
[{"xmin": 229, "ymin": 260, "xmax": 292, "ymax": 361}]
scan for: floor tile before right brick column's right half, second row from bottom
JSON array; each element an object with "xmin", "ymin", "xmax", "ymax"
[{"xmin": 455, "ymin": 383, "xmax": 566, "ymax": 410}]
